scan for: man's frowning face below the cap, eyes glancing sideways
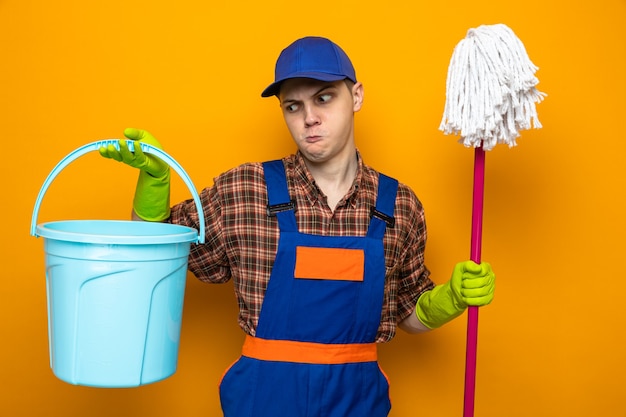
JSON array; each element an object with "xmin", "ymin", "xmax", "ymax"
[{"xmin": 278, "ymin": 78, "xmax": 363, "ymax": 164}]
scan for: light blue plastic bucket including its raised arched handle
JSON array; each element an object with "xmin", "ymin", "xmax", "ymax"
[{"xmin": 30, "ymin": 139, "xmax": 204, "ymax": 388}]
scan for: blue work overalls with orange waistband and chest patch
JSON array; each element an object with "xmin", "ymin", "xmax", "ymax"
[{"xmin": 220, "ymin": 161, "xmax": 398, "ymax": 417}]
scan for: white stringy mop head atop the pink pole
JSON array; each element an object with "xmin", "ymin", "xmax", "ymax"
[{"xmin": 439, "ymin": 24, "xmax": 546, "ymax": 150}]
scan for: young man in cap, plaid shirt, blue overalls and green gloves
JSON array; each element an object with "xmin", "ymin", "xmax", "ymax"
[{"xmin": 101, "ymin": 37, "xmax": 495, "ymax": 417}]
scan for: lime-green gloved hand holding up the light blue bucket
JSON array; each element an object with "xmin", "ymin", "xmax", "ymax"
[{"xmin": 100, "ymin": 128, "xmax": 170, "ymax": 222}]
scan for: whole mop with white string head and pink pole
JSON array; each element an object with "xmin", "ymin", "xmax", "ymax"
[{"xmin": 439, "ymin": 24, "xmax": 546, "ymax": 417}]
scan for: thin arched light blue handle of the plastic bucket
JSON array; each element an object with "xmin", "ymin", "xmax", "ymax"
[{"xmin": 30, "ymin": 139, "xmax": 205, "ymax": 243}]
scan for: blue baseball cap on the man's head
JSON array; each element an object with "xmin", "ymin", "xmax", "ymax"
[{"xmin": 261, "ymin": 36, "xmax": 356, "ymax": 97}]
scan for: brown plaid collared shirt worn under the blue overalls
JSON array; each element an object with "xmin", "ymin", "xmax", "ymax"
[{"xmin": 170, "ymin": 153, "xmax": 434, "ymax": 342}]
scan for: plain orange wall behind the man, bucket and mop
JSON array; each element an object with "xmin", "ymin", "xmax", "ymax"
[{"xmin": 0, "ymin": 0, "xmax": 626, "ymax": 417}]
